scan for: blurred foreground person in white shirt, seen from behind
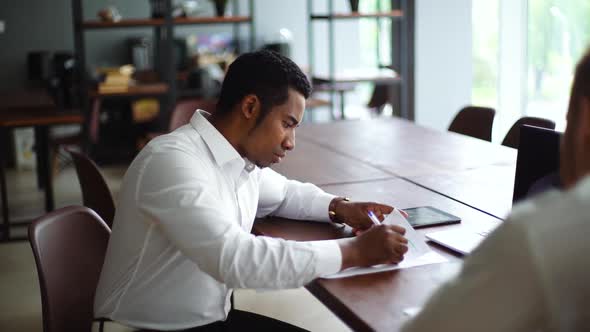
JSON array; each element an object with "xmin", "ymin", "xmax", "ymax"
[{"xmin": 403, "ymin": 48, "xmax": 590, "ymax": 332}]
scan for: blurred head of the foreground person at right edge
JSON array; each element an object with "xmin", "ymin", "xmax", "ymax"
[{"xmin": 560, "ymin": 97, "xmax": 590, "ymax": 188}]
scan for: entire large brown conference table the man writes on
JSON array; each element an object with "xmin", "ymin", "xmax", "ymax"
[{"xmin": 254, "ymin": 119, "xmax": 516, "ymax": 331}]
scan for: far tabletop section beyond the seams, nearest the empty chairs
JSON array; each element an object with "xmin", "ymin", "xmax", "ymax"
[{"xmin": 297, "ymin": 118, "xmax": 516, "ymax": 177}]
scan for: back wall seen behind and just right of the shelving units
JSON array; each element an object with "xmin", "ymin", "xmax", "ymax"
[{"xmin": 0, "ymin": 0, "xmax": 472, "ymax": 130}]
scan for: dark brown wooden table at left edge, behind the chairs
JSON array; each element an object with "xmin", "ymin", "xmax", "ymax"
[{"xmin": 0, "ymin": 90, "xmax": 83, "ymax": 240}]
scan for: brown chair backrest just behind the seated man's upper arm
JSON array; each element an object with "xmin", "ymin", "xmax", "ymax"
[{"xmin": 65, "ymin": 148, "xmax": 115, "ymax": 227}]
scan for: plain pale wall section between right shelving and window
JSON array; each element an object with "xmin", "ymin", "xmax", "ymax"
[{"xmin": 414, "ymin": 0, "xmax": 472, "ymax": 130}]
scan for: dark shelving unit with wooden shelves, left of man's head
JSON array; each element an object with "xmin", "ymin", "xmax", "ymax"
[{"xmin": 72, "ymin": 0, "xmax": 255, "ymax": 146}]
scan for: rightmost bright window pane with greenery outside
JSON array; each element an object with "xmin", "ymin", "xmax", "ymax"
[{"xmin": 525, "ymin": 0, "xmax": 590, "ymax": 130}]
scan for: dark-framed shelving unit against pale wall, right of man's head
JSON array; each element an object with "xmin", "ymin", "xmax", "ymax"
[{"xmin": 307, "ymin": 0, "xmax": 414, "ymax": 120}]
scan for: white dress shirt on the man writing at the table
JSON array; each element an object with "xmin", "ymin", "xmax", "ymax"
[{"xmin": 94, "ymin": 111, "xmax": 342, "ymax": 330}]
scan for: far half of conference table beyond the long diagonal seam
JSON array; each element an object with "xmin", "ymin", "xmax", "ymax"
[{"xmin": 296, "ymin": 118, "xmax": 517, "ymax": 218}]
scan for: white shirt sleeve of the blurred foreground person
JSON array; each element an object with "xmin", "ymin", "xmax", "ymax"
[{"xmin": 403, "ymin": 206, "xmax": 547, "ymax": 332}]
